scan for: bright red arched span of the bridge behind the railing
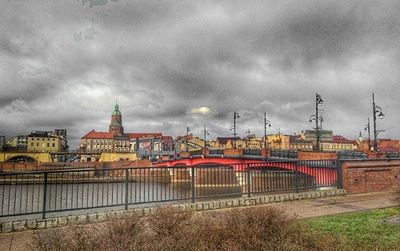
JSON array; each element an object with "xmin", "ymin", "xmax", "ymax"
[{"xmin": 153, "ymin": 157, "xmax": 337, "ymax": 186}]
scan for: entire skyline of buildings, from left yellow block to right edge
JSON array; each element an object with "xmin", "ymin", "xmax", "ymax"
[{"xmin": 0, "ymin": 104, "xmax": 400, "ymax": 161}]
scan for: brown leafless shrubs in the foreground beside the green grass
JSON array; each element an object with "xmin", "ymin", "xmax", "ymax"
[{"xmin": 31, "ymin": 207, "xmax": 340, "ymax": 251}]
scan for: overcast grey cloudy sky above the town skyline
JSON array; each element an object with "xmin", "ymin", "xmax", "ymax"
[{"xmin": 0, "ymin": 0, "xmax": 400, "ymax": 148}]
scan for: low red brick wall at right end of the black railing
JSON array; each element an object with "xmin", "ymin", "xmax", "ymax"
[{"xmin": 342, "ymin": 160, "xmax": 400, "ymax": 194}]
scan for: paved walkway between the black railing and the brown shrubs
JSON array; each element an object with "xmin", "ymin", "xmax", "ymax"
[{"xmin": 0, "ymin": 192, "xmax": 396, "ymax": 251}]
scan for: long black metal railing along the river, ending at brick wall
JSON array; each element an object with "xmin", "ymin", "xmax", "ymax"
[{"xmin": 0, "ymin": 160, "xmax": 337, "ymax": 218}]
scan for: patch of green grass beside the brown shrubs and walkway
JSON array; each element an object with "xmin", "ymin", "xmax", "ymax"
[{"xmin": 306, "ymin": 207, "xmax": 400, "ymax": 250}]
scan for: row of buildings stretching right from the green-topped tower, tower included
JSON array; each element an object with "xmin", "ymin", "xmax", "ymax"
[{"xmin": 80, "ymin": 104, "xmax": 394, "ymax": 159}]
